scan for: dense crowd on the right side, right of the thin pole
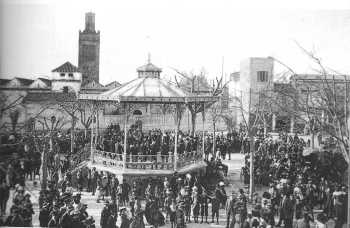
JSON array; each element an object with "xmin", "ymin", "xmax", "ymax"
[{"xmin": 242, "ymin": 130, "xmax": 348, "ymax": 228}]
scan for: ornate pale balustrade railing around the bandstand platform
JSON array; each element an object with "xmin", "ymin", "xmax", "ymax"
[{"xmin": 92, "ymin": 149, "xmax": 203, "ymax": 170}]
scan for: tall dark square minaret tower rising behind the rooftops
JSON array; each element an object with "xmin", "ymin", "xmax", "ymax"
[{"xmin": 78, "ymin": 12, "xmax": 100, "ymax": 85}]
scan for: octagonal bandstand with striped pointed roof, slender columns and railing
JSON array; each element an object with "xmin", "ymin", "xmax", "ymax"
[{"xmin": 79, "ymin": 61, "xmax": 217, "ymax": 183}]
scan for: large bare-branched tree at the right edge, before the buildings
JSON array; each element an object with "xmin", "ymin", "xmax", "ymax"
[{"xmin": 274, "ymin": 43, "xmax": 350, "ymax": 163}]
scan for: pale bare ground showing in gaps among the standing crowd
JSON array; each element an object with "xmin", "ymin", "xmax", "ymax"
[{"xmin": 2, "ymin": 154, "xmax": 342, "ymax": 228}]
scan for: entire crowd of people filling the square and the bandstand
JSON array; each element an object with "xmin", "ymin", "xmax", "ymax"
[{"xmin": 0, "ymin": 124, "xmax": 348, "ymax": 228}]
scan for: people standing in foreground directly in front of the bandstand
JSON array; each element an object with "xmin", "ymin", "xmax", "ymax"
[{"xmin": 90, "ymin": 170, "xmax": 227, "ymax": 228}]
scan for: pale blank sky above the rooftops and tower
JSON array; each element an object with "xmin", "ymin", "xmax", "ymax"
[{"xmin": 0, "ymin": 0, "xmax": 350, "ymax": 84}]
